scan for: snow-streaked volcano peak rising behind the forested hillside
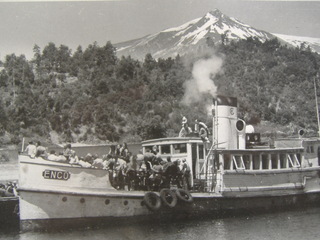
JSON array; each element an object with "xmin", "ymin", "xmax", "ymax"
[{"xmin": 115, "ymin": 9, "xmax": 275, "ymax": 59}]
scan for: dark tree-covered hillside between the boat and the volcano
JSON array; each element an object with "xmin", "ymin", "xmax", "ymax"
[{"xmin": 0, "ymin": 38, "xmax": 320, "ymax": 144}]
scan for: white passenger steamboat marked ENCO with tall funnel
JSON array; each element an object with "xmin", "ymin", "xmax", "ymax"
[{"xmin": 18, "ymin": 96, "xmax": 320, "ymax": 231}]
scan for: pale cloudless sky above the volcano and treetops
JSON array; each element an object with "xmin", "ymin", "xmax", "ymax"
[{"xmin": 0, "ymin": 0, "xmax": 320, "ymax": 60}]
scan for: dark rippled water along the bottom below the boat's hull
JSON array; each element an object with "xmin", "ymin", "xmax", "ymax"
[{"xmin": 0, "ymin": 208, "xmax": 320, "ymax": 240}]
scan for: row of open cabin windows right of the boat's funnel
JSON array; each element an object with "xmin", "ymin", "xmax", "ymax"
[{"xmin": 223, "ymin": 154, "xmax": 301, "ymax": 170}]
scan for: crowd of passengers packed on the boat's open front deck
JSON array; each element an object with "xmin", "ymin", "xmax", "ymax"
[{"xmin": 25, "ymin": 142, "xmax": 191, "ymax": 191}]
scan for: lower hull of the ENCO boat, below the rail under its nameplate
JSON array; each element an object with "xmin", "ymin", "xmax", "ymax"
[{"xmin": 20, "ymin": 187, "xmax": 320, "ymax": 231}]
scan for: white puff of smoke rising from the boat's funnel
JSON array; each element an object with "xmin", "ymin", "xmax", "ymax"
[{"xmin": 182, "ymin": 56, "xmax": 223, "ymax": 105}]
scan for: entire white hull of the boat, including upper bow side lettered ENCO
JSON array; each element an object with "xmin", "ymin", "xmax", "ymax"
[{"xmin": 19, "ymin": 153, "xmax": 320, "ymax": 231}]
